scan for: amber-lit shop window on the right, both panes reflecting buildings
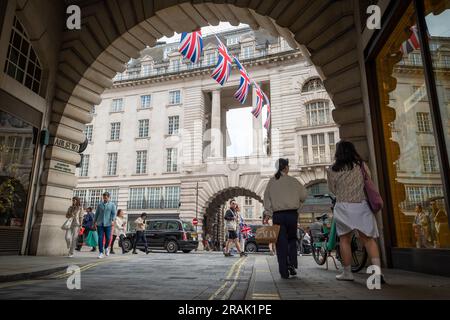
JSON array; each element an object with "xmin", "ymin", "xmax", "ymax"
[{"xmin": 375, "ymin": 0, "xmax": 450, "ymax": 249}]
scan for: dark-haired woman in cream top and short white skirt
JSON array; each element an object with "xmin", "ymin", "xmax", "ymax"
[{"xmin": 328, "ymin": 141, "xmax": 384, "ymax": 283}]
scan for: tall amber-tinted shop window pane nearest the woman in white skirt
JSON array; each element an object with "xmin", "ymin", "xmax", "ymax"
[{"xmin": 376, "ymin": 1, "xmax": 450, "ymax": 248}]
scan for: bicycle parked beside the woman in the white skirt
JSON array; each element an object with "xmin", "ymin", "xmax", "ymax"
[{"xmin": 310, "ymin": 194, "xmax": 368, "ymax": 273}]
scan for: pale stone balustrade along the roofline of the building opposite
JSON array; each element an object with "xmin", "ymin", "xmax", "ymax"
[{"xmin": 113, "ymin": 49, "xmax": 297, "ymax": 83}]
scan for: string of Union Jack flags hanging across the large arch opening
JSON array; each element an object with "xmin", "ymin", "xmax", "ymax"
[{"xmin": 178, "ymin": 30, "xmax": 272, "ymax": 130}]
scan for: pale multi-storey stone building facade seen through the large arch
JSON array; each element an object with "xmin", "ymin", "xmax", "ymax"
[{"xmin": 75, "ymin": 28, "xmax": 339, "ymax": 237}]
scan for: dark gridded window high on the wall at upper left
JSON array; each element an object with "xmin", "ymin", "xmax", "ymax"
[{"xmin": 4, "ymin": 17, "xmax": 42, "ymax": 94}]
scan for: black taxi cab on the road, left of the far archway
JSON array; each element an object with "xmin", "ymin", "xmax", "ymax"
[{"xmin": 124, "ymin": 219, "xmax": 198, "ymax": 253}]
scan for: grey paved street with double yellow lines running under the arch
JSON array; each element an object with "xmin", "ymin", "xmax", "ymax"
[{"xmin": 0, "ymin": 251, "xmax": 450, "ymax": 300}]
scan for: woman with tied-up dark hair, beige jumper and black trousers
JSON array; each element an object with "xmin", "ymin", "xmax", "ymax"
[{"xmin": 264, "ymin": 159, "xmax": 307, "ymax": 279}]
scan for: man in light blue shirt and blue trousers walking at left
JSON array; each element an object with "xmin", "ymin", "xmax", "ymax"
[{"xmin": 94, "ymin": 192, "xmax": 116, "ymax": 259}]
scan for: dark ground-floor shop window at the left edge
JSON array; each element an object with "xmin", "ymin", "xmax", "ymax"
[{"xmin": 0, "ymin": 111, "xmax": 36, "ymax": 252}]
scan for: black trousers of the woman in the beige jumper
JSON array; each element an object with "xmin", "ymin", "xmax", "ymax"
[{"xmin": 273, "ymin": 210, "xmax": 298, "ymax": 277}]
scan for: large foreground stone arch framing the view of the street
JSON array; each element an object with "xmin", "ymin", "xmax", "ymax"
[{"xmin": 31, "ymin": 0, "xmax": 368, "ymax": 255}]
